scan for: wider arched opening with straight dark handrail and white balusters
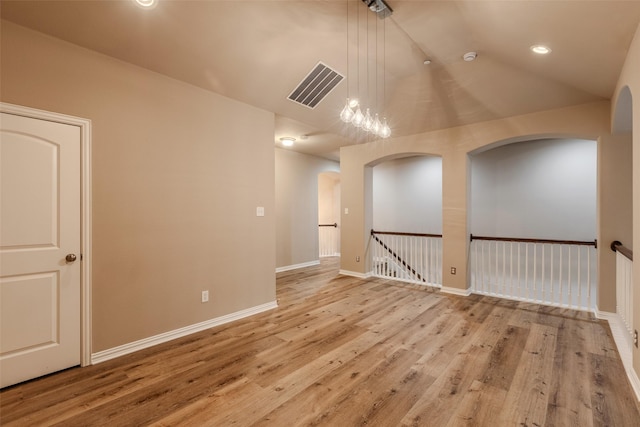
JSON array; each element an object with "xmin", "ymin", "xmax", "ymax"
[{"xmin": 469, "ymin": 138, "xmax": 598, "ymax": 310}]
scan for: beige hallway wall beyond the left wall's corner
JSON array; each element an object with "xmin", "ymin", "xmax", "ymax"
[{"xmin": 275, "ymin": 148, "xmax": 340, "ymax": 268}]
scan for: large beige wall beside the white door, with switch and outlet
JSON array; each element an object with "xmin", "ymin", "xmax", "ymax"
[{"xmin": 0, "ymin": 21, "xmax": 276, "ymax": 353}]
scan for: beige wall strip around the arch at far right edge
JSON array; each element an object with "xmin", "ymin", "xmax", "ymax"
[{"xmin": 612, "ymin": 20, "xmax": 640, "ymax": 382}]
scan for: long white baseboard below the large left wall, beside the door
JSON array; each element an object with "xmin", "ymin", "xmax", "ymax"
[{"xmin": 91, "ymin": 301, "xmax": 278, "ymax": 364}]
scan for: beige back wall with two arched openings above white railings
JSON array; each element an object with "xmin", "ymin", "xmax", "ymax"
[{"xmin": 340, "ymin": 101, "xmax": 614, "ymax": 296}]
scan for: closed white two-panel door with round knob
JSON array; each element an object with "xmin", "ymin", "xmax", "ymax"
[{"xmin": 0, "ymin": 113, "xmax": 81, "ymax": 387}]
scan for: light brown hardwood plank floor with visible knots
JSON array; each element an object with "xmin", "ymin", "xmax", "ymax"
[{"xmin": 0, "ymin": 259, "xmax": 640, "ymax": 427}]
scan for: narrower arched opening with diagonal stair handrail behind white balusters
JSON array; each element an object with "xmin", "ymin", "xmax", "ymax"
[{"xmin": 367, "ymin": 155, "xmax": 442, "ymax": 286}]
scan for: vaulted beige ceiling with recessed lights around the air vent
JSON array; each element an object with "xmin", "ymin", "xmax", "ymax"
[{"xmin": 0, "ymin": 0, "xmax": 640, "ymax": 159}]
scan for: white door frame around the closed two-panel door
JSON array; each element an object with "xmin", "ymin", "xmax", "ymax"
[{"xmin": 0, "ymin": 102, "xmax": 91, "ymax": 366}]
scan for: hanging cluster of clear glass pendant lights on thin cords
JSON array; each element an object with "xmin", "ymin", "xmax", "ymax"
[{"xmin": 340, "ymin": 0, "xmax": 393, "ymax": 138}]
